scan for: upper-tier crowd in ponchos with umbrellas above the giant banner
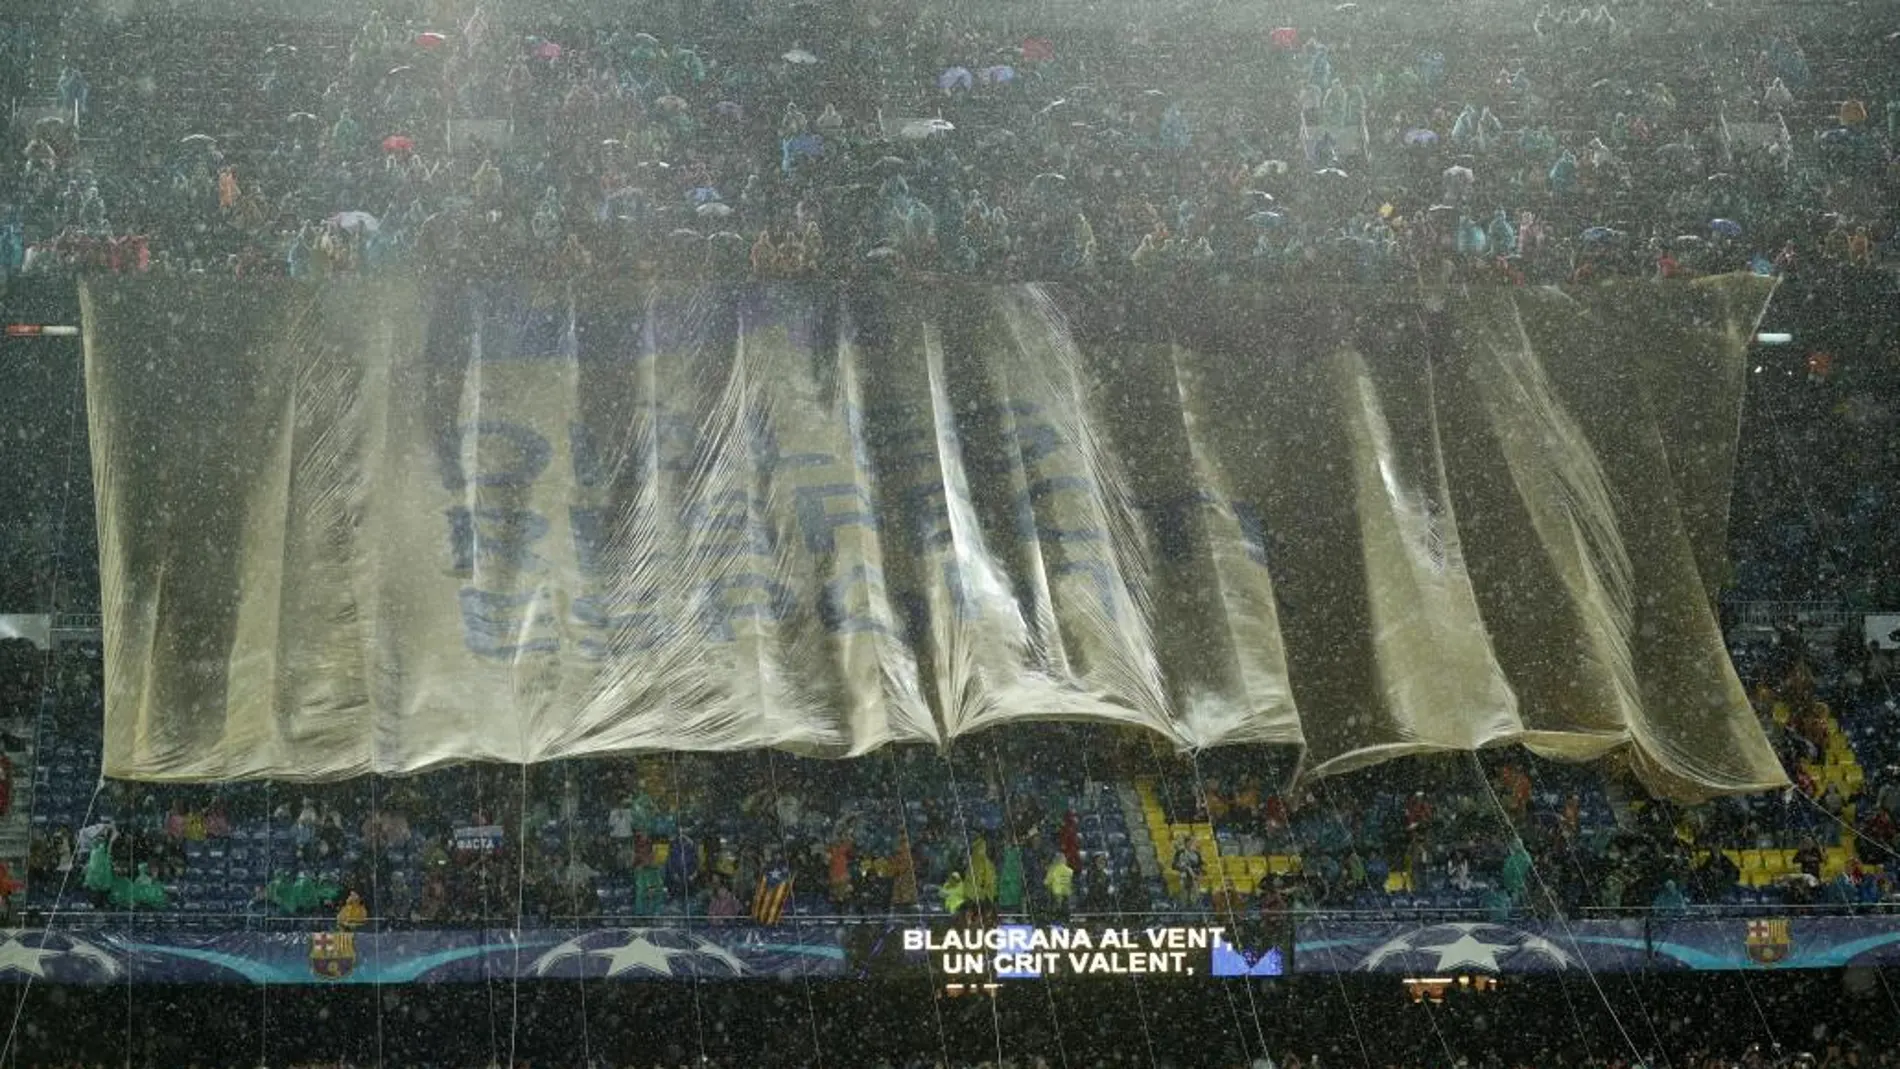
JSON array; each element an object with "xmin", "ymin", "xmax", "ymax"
[{"xmin": 0, "ymin": 0, "xmax": 1900, "ymax": 283}]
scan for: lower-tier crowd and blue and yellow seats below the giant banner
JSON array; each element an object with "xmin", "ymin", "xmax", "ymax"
[{"xmin": 0, "ymin": 592, "xmax": 1900, "ymax": 927}]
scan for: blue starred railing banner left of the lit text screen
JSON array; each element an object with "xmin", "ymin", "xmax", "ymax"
[{"xmin": 0, "ymin": 927, "xmax": 846, "ymax": 984}]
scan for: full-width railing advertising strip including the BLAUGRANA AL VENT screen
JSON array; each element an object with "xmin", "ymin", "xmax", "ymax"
[{"xmin": 14, "ymin": 915, "xmax": 1900, "ymax": 985}]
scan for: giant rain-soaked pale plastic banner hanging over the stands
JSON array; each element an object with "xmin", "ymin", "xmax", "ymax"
[{"xmin": 84, "ymin": 277, "xmax": 1782, "ymax": 796}]
